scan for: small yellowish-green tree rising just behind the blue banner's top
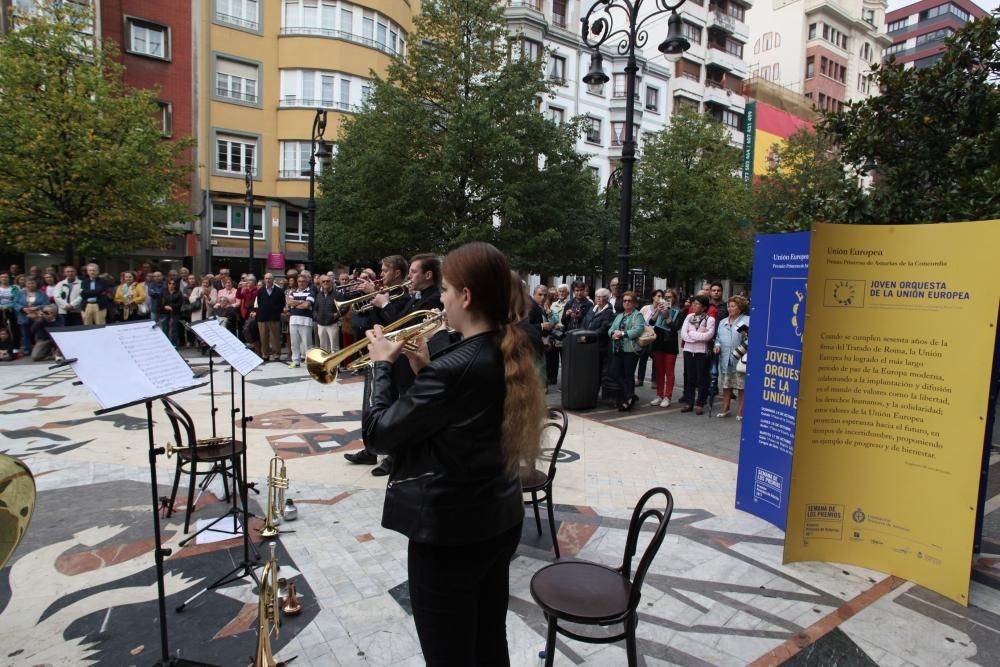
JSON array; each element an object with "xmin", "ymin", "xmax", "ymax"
[{"xmin": 752, "ymin": 128, "xmax": 864, "ymax": 233}]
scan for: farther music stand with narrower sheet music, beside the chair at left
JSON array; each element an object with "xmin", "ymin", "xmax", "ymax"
[{"xmin": 176, "ymin": 319, "xmax": 264, "ymax": 613}]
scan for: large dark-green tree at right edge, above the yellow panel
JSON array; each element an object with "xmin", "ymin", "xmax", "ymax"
[{"xmin": 820, "ymin": 13, "xmax": 1000, "ymax": 224}]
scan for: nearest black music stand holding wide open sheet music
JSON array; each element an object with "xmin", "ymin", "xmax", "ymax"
[{"xmin": 51, "ymin": 320, "xmax": 213, "ymax": 667}]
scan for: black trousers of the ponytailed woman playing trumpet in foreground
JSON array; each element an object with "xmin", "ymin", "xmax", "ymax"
[{"xmin": 407, "ymin": 523, "xmax": 521, "ymax": 667}]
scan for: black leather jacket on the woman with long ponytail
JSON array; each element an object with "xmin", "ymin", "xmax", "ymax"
[{"xmin": 362, "ymin": 332, "xmax": 524, "ymax": 545}]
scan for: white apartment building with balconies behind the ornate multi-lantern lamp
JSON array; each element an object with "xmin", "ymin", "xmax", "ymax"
[{"xmin": 506, "ymin": 0, "xmax": 749, "ymax": 188}]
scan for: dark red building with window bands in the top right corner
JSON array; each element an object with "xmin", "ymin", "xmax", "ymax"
[{"xmin": 882, "ymin": 0, "xmax": 986, "ymax": 69}]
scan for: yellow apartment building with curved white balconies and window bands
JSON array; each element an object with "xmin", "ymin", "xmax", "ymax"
[{"xmin": 195, "ymin": 0, "xmax": 419, "ymax": 275}]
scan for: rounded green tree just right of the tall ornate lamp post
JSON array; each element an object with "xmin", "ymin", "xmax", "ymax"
[{"xmin": 632, "ymin": 110, "xmax": 753, "ymax": 284}]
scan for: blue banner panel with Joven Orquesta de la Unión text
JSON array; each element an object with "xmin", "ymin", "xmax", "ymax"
[{"xmin": 736, "ymin": 232, "xmax": 809, "ymax": 530}]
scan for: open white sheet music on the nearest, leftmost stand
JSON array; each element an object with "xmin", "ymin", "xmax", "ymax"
[{"xmin": 50, "ymin": 320, "xmax": 200, "ymax": 409}]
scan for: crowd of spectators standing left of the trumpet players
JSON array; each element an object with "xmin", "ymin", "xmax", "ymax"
[{"xmin": 0, "ymin": 262, "xmax": 386, "ymax": 367}]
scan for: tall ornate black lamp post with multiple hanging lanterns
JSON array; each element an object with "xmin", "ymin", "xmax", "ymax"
[{"xmin": 580, "ymin": 0, "xmax": 691, "ymax": 288}]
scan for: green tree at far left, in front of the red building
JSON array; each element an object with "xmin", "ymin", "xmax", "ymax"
[{"xmin": 0, "ymin": 0, "xmax": 191, "ymax": 261}]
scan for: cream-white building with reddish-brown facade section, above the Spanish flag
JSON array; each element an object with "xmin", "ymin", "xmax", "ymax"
[{"xmin": 748, "ymin": 0, "xmax": 891, "ymax": 111}]
